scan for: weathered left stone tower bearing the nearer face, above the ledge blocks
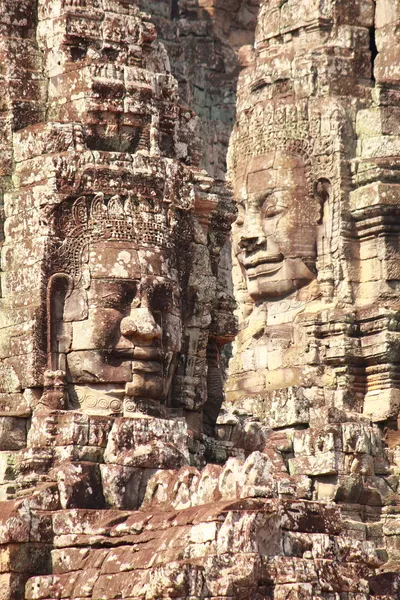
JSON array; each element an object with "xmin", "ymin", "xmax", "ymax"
[{"xmin": 0, "ymin": 1, "xmax": 233, "ymax": 431}]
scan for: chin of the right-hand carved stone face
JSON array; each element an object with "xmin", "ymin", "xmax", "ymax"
[{"xmin": 246, "ymin": 258, "xmax": 315, "ymax": 302}]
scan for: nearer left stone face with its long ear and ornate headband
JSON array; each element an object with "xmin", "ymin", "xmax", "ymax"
[{"xmin": 51, "ymin": 195, "xmax": 182, "ymax": 412}]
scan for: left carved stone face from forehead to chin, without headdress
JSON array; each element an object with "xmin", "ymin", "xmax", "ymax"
[{"xmin": 64, "ymin": 241, "xmax": 181, "ymax": 411}]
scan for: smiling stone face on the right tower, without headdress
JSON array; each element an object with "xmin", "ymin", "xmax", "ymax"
[{"xmin": 233, "ymin": 151, "xmax": 320, "ymax": 301}]
